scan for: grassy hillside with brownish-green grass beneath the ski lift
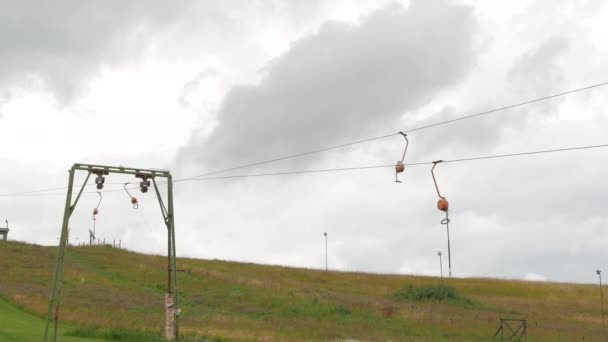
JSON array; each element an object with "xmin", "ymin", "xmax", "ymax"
[{"xmin": 0, "ymin": 241, "xmax": 608, "ymax": 341}]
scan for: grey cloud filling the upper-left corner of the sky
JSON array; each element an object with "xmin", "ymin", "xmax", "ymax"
[{"xmin": 0, "ymin": 0, "xmax": 183, "ymax": 101}]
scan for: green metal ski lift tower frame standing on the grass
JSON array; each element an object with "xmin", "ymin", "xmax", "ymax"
[{"xmin": 43, "ymin": 164, "xmax": 180, "ymax": 342}]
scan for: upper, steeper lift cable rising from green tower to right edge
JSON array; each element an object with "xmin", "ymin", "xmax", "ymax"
[{"xmin": 174, "ymin": 82, "xmax": 608, "ymax": 182}]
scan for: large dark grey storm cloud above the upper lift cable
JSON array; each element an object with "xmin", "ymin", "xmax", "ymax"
[{"xmin": 181, "ymin": 1, "xmax": 476, "ymax": 171}]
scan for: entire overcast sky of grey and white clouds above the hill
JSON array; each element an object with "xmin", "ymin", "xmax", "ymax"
[{"xmin": 0, "ymin": 0, "xmax": 608, "ymax": 283}]
